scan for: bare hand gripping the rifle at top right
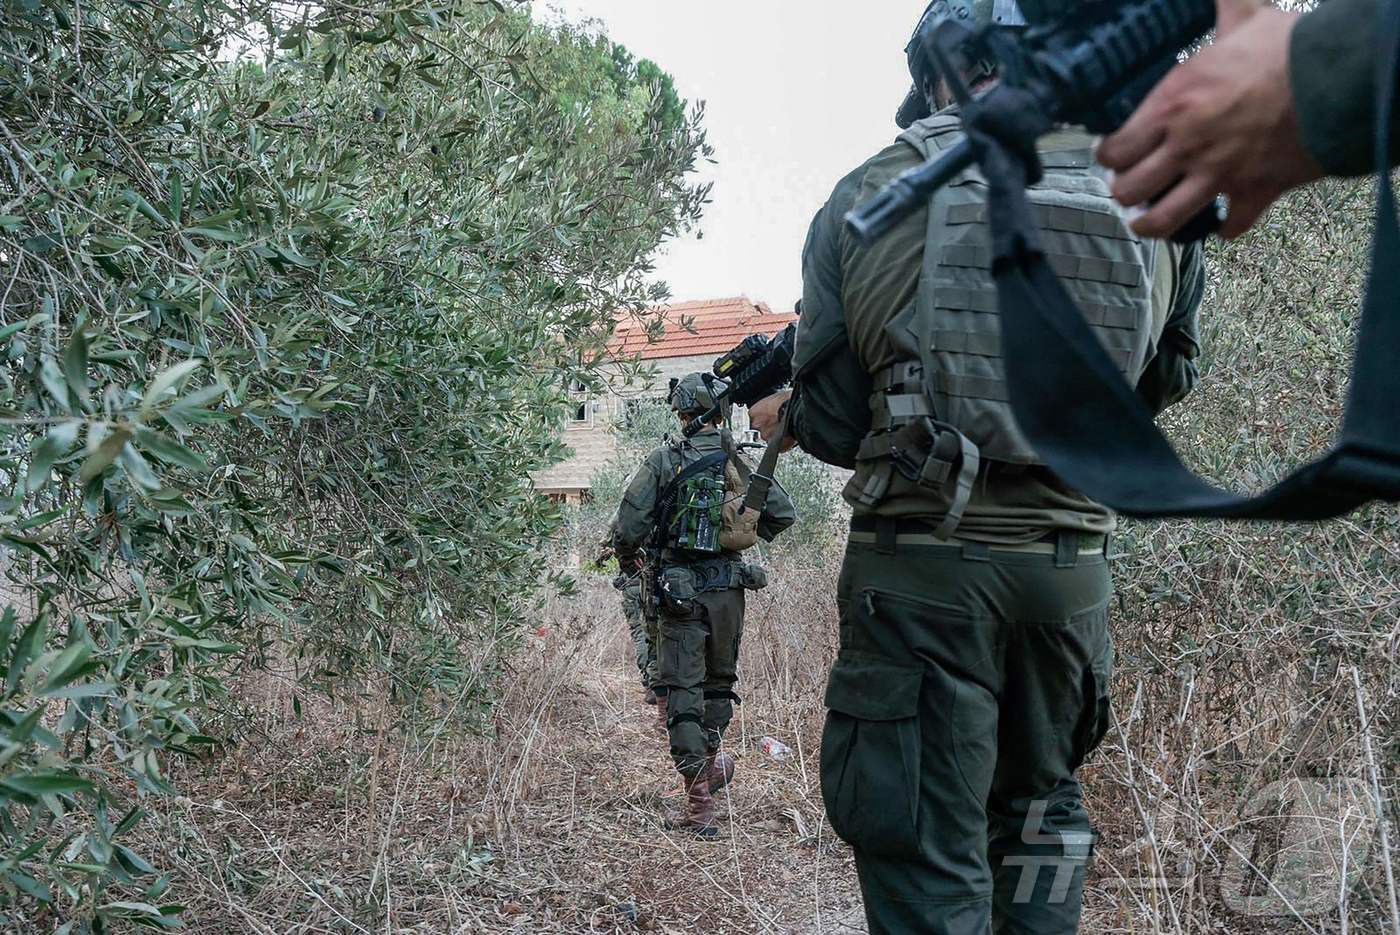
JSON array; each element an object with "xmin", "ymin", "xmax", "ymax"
[{"xmin": 1099, "ymin": 0, "xmax": 1323, "ymax": 238}]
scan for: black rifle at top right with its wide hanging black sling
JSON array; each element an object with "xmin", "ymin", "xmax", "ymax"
[{"xmin": 848, "ymin": 0, "xmax": 1400, "ymax": 521}]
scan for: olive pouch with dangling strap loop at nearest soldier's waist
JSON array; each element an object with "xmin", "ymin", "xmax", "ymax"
[{"xmin": 846, "ymin": 363, "xmax": 981, "ymax": 537}]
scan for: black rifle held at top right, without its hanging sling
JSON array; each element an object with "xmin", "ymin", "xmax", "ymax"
[{"xmin": 846, "ymin": 0, "xmax": 1219, "ymax": 245}]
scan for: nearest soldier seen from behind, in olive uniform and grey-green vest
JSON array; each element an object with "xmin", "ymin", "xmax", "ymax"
[{"xmin": 750, "ymin": 0, "xmax": 1204, "ymax": 935}]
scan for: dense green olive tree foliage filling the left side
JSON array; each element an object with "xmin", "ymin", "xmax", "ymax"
[{"xmin": 0, "ymin": 0, "xmax": 704, "ymax": 931}]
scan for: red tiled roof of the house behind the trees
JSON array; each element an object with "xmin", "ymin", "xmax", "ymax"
[{"xmin": 610, "ymin": 295, "xmax": 797, "ymax": 360}]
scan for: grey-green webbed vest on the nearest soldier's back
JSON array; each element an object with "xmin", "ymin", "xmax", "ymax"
[{"xmin": 901, "ymin": 113, "xmax": 1158, "ymax": 466}]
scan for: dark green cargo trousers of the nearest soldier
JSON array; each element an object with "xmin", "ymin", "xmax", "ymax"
[{"xmin": 822, "ymin": 535, "xmax": 1112, "ymax": 935}]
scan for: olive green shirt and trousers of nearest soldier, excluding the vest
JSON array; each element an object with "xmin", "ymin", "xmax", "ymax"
[{"xmin": 788, "ymin": 116, "xmax": 1203, "ymax": 935}]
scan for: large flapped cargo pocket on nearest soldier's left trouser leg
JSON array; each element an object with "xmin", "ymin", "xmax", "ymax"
[{"xmin": 822, "ymin": 651, "xmax": 924, "ymax": 858}]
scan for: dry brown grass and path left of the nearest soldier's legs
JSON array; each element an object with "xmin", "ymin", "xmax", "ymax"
[{"xmin": 117, "ymin": 565, "xmax": 858, "ymax": 934}]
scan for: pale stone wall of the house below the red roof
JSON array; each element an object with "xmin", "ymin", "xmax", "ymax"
[{"xmin": 535, "ymin": 354, "xmax": 749, "ymax": 500}]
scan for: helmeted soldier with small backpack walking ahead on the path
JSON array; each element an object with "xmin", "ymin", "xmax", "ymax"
[{"xmin": 615, "ymin": 374, "xmax": 795, "ymax": 837}]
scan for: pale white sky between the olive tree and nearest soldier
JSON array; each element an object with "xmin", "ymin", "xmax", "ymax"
[{"xmin": 536, "ymin": 0, "xmax": 925, "ymax": 311}]
